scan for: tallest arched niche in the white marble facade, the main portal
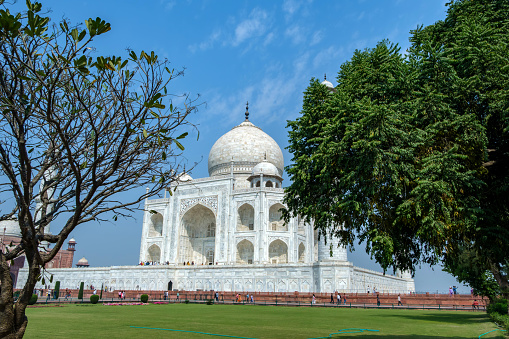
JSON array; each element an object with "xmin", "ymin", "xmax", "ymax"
[{"xmin": 179, "ymin": 204, "xmax": 216, "ymax": 265}]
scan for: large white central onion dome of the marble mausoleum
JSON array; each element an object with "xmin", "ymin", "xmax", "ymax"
[{"xmin": 209, "ymin": 119, "xmax": 284, "ymax": 176}]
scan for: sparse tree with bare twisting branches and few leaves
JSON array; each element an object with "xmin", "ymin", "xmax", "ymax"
[{"xmin": 0, "ymin": 1, "xmax": 196, "ymax": 338}]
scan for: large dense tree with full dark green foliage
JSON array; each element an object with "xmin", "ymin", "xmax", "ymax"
[{"xmin": 285, "ymin": 0, "xmax": 509, "ymax": 287}]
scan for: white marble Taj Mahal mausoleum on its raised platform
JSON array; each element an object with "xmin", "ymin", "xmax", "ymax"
[{"xmin": 17, "ymin": 99, "xmax": 415, "ymax": 293}]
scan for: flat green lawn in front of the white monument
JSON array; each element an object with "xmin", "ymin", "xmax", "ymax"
[{"xmin": 25, "ymin": 304, "xmax": 504, "ymax": 339}]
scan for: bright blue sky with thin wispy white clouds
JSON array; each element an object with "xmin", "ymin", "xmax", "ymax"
[{"xmin": 9, "ymin": 0, "xmax": 467, "ymax": 292}]
